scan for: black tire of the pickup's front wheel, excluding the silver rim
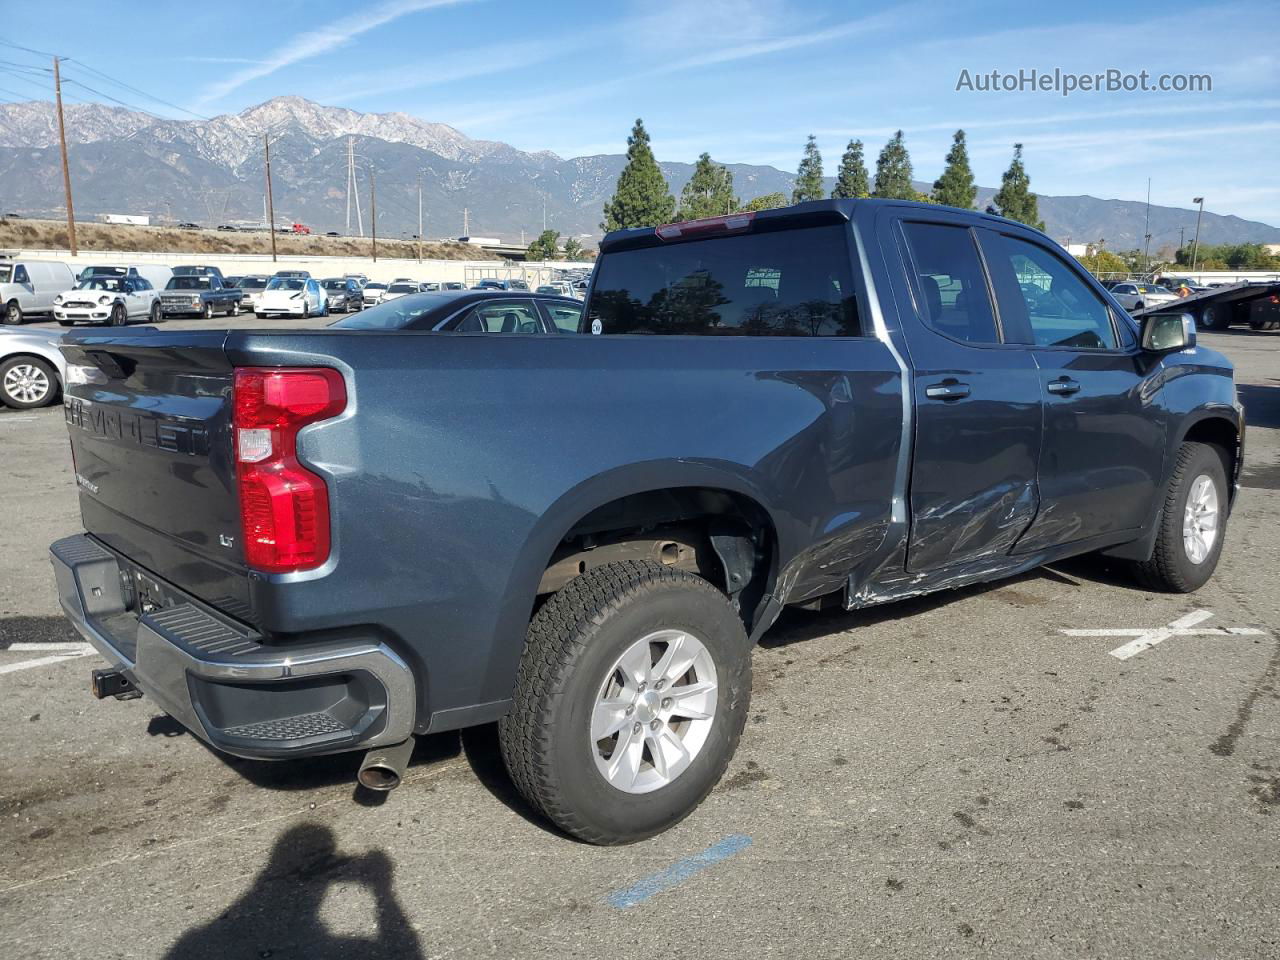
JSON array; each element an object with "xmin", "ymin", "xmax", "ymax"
[{"xmin": 1134, "ymin": 443, "xmax": 1228, "ymax": 594}]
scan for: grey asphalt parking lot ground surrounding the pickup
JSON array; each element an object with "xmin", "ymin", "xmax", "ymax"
[{"xmin": 0, "ymin": 316, "xmax": 1280, "ymax": 957}]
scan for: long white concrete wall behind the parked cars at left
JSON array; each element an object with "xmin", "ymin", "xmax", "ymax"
[{"xmin": 6, "ymin": 250, "xmax": 594, "ymax": 287}]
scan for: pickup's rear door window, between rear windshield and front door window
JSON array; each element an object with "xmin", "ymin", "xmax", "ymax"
[{"xmin": 902, "ymin": 223, "xmax": 1000, "ymax": 343}]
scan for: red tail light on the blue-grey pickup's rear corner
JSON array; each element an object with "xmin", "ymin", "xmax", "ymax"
[{"xmin": 232, "ymin": 367, "xmax": 347, "ymax": 573}]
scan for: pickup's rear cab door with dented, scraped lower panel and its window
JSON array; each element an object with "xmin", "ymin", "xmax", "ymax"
[{"xmin": 886, "ymin": 212, "xmax": 1041, "ymax": 573}]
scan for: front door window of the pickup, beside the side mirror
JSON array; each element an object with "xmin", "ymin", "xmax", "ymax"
[{"xmin": 993, "ymin": 234, "xmax": 1116, "ymax": 349}]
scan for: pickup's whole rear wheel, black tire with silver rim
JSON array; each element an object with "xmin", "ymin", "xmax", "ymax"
[{"xmin": 498, "ymin": 561, "xmax": 751, "ymax": 844}]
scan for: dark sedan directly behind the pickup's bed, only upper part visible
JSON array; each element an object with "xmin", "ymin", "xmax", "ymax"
[{"xmin": 329, "ymin": 291, "xmax": 582, "ymax": 333}]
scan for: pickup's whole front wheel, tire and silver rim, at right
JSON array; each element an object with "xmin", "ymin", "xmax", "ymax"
[{"xmin": 1135, "ymin": 443, "xmax": 1228, "ymax": 594}]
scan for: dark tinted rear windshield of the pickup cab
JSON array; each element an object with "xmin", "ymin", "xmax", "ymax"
[{"xmin": 589, "ymin": 224, "xmax": 863, "ymax": 337}]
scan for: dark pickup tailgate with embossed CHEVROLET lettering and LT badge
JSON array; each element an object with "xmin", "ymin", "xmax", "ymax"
[{"xmin": 63, "ymin": 330, "xmax": 250, "ymax": 618}]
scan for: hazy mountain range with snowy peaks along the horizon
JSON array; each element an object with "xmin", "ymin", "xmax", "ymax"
[{"xmin": 0, "ymin": 96, "xmax": 1280, "ymax": 252}]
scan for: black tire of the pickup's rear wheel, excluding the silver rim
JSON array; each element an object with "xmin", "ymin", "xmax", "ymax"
[{"xmin": 498, "ymin": 561, "xmax": 751, "ymax": 844}]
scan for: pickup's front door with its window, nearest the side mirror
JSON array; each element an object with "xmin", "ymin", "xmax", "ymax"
[{"xmin": 980, "ymin": 229, "xmax": 1166, "ymax": 553}]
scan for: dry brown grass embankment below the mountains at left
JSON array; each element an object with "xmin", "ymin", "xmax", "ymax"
[{"xmin": 0, "ymin": 218, "xmax": 500, "ymax": 260}]
